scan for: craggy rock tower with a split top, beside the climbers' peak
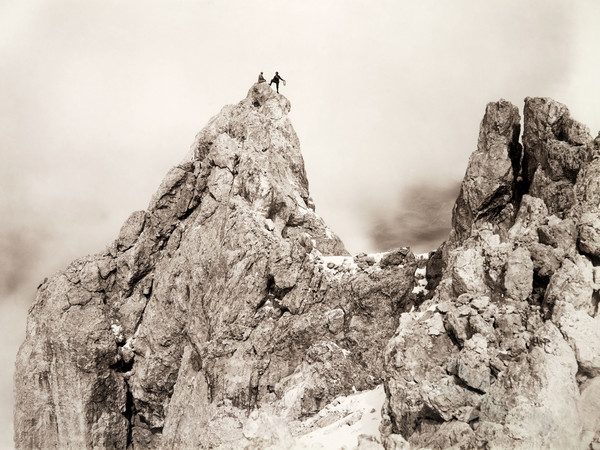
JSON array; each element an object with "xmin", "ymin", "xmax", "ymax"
[{"xmin": 381, "ymin": 98, "xmax": 600, "ymax": 449}]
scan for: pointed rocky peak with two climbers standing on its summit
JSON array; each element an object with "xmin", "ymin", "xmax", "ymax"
[{"xmin": 15, "ymin": 83, "xmax": 416, "ymax": 448}]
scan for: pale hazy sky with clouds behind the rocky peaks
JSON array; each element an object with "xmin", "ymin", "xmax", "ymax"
[{"xmin": 0, "ymin": 0, "xmax": 600, "ymax": 447}]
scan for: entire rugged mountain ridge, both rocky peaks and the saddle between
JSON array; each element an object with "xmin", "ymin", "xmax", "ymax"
[{"xmin": 15, "ymin": 83, "xmax": 600, "ymax": 450}]
